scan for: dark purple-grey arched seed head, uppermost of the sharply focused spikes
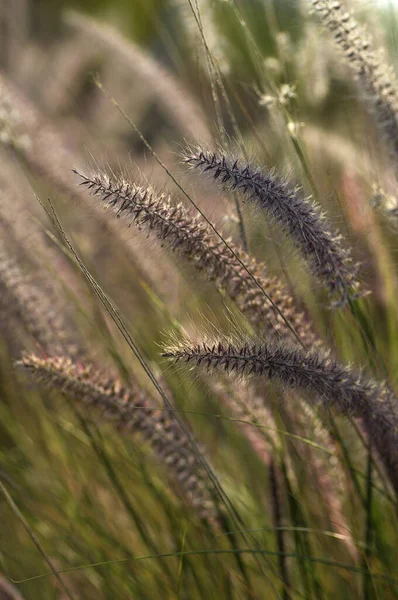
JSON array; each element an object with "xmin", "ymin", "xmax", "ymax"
[{"xmin": 184, "ymin": 147, "xmax": 358, "ymax": 301}]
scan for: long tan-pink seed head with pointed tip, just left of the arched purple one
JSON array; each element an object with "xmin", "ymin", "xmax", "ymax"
[{"xmin": 75, "ymin": 171, "xmax": 317, "ymax": 344}]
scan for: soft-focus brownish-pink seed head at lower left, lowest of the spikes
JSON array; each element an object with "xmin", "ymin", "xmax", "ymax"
[{"xmin": 17, "ymin": 355, "xmax": 217, "ymax": 522}]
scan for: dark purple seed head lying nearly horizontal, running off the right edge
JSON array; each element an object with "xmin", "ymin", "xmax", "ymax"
[{"xmin": 164, "ymin": 343, "xmax": 398, "ymax": 491}]
